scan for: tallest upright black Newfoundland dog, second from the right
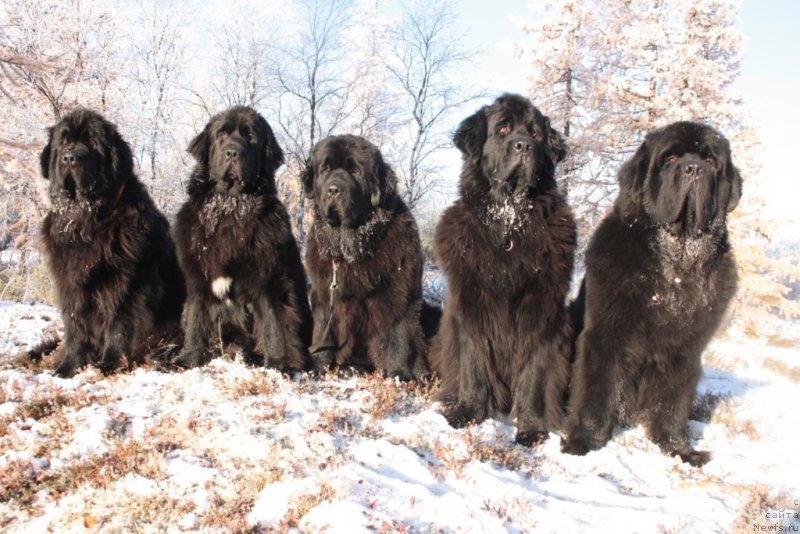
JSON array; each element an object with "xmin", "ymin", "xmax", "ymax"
[{"xmin": 431, "ymin": 95, "xmax": 576, "ymax": 445}]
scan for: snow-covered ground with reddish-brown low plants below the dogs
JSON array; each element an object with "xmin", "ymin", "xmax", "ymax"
[{"xmin": 0, "ymin": 303, "xmax": 800, "ymax": 533}]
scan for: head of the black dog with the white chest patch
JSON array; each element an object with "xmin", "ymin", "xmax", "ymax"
[{"xmin": 188, "ymin": 106, "xmax": 283, "ymax": 196}]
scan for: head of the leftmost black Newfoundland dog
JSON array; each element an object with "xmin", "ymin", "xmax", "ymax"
[{"xmin": 39, "ymin": 108, "xmax": 133, "ymax": 205}]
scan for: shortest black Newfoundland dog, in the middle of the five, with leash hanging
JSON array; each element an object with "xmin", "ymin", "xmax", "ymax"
[{"xmin": 303, "ymin": 135, "xmax": 427, "ymax": 380}]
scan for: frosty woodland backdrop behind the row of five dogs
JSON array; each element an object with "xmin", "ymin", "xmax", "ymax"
[{"xmin": 0, "ymin": 0, "xmax": 800, "ymax": 324}]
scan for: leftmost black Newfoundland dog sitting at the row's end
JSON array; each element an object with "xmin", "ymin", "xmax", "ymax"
[{"xmin": 40, "ymin": 109, "xmax": 185, "ymax": 376}]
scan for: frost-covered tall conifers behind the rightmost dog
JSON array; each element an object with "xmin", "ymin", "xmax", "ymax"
[{"xmin": 518, "ymin": 0, "xmax": 800, "ymax": 315}]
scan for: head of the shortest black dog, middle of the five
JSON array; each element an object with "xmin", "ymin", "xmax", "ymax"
[{"xmin": 302, "ymin": 135, "xmax": 397, "ymax": 228}]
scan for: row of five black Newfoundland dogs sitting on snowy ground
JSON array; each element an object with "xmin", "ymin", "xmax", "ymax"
[{"xmin": 36, "ymin": 94, "xmax": 741, "ymax": 465}]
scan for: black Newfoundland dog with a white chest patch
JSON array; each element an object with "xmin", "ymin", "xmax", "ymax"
[{"xmin": 172, "ymin": 106, "xmax": 312, "ymax": 370}]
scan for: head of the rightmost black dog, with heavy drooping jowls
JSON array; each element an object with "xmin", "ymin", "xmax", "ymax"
[{"xmin": 618, "ymin": 122, "xmax": 742, "ymax": 235}]
